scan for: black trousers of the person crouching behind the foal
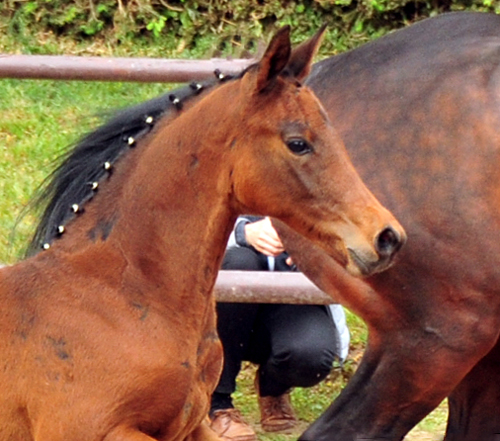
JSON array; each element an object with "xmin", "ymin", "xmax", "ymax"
[{"xmin": 212, "ymin": 247, "xmax": 337, "ymax": 411}]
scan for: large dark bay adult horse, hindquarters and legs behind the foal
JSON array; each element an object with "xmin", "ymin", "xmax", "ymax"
[{"xmin": 281, "ymin": 9, "xmax": 500, "ymax": 441}]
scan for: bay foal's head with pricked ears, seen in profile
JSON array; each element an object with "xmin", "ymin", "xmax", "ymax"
[{"xmin": 225, "ymin": 28, "xmax": 405, "ymax": 275}]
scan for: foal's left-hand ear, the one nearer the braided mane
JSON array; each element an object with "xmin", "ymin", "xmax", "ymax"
[{"xmin": 257, "ymin": 26, "xmax": 292, "ymax": 92}]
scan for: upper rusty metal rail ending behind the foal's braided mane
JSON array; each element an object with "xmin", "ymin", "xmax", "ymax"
[{"xmin": 0, "ymin": 54, "xmax": 253, "ymax": 83}]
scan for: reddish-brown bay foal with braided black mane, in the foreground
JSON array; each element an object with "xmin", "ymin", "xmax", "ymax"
[{"xmin": 0, "ymin": 28, "xmax": 405, "ymax": 441}]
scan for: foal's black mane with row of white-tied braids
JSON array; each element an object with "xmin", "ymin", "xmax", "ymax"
[{"xmin": 26, "ymin": 68, "xmax": 248, "ymax": 257}]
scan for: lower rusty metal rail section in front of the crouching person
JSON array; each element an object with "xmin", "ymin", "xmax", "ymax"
[{"xmin": 215, "ymin": 270, "xmax": 335, "ymax": 305}]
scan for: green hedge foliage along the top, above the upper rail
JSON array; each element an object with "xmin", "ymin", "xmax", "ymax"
[{"xmin": 0, "ymin": 0, "xmax": 500, "ymax": 57}]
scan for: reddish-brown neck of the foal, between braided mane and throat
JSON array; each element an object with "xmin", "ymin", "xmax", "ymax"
[{"xmin": 109, "ymin": 85, "xmax": 241, "ymax": 298}]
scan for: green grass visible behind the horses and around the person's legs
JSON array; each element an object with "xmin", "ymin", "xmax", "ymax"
[{"xmin": 0, "ymin": 80, "xmax": 446, "ymax": 441}]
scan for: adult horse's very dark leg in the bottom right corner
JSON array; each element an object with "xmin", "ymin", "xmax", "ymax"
[{"xmin": 445, "ymin": 343, "xmax": 500, "ymax": 441}]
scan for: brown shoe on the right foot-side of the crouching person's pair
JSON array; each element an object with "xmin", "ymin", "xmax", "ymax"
[{"xmin": 255, "ymin": 373, "xmax": 297, "ymax": 432}]
